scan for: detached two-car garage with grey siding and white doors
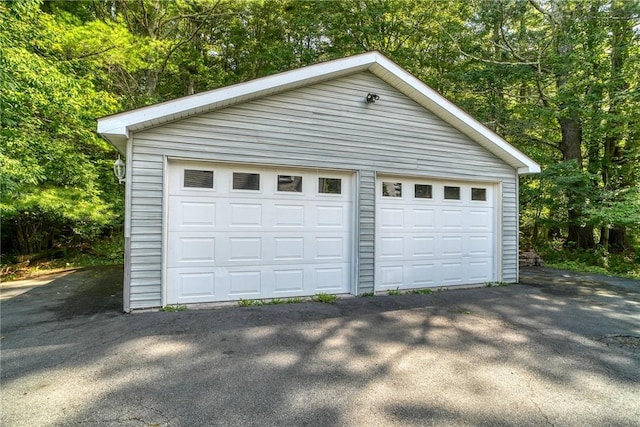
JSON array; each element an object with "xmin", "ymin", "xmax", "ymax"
[{"xmin": 98, "ymin": 52, "xmax": 540, "ymax": 311}]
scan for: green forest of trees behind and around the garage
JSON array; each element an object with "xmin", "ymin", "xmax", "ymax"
[{"xmin": 0, "ymin": 0, "xmax": 640, "ymax": 277}]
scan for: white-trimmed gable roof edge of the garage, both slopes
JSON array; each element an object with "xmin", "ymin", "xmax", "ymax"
[{"xmin": 98, "ymin": 52, "xmax": 540, "ymax": 175}]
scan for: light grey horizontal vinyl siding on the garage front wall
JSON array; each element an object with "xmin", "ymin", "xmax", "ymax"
[{"xmin": 128, "ymin": 72, "xmax": 517, "ymax": 308}]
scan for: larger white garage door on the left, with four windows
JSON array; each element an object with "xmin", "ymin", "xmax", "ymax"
[{"xmin": 165, "ymin": 162, "xmax": 353, "ymax": 304}]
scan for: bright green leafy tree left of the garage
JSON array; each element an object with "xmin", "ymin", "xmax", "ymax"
[{"xmin": 0, "ymin": 1, "xmax": 119, "ymax": 253}]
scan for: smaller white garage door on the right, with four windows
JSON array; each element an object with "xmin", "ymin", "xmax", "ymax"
[{"xmin": 375, "ymin": 177, "xmax": 497, "ymax": 291}]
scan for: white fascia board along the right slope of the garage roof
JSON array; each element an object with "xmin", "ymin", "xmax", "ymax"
[{"xmin": 371, "ymin": 53, "xmax": 540, "ymax": 175}]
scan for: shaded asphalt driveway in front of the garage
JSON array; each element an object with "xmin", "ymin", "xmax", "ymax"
[{"xmin": 0, "ymin": 267, "xmax": 640, "ymax": 426}]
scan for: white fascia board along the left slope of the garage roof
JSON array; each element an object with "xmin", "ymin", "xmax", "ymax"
[{"xmin": 98, "ymin": 52, "xmax": 376, "ymax": 141}]
